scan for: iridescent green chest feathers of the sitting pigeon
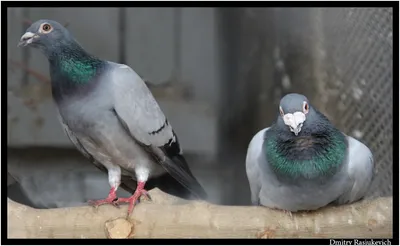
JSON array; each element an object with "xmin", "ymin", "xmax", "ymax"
[{"xmin": 264, "ymin": 136, "xmax": 347, "ymax": 179}]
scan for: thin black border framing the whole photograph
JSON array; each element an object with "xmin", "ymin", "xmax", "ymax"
[{"xmin": 1, "ymin": 1, "xmax": 399, "ymax": 245}]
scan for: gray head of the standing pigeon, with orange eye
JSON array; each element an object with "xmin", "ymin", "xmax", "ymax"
[{"xmin": 18, "ymin": 20, "xmax": 71, "ymax": 51}]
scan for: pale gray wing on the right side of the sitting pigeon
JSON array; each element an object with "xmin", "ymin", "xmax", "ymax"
[{"xmin": 335, "ymin": 136, "xmax": 374, "ymax": 204}]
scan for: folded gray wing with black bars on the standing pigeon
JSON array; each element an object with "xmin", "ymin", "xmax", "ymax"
[{"xmin": 110, "ymin": 63, "xmax": 206, "ymax": 198}]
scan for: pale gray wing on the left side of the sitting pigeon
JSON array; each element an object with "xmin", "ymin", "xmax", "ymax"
[{"xmin": 246, "ymin": 128, "xmax": 269, "ymax": 205}]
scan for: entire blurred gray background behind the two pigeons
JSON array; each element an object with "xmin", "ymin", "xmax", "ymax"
[{"xmin": 7, "ymin": 8, "xmax": 393, "ymax": 208}]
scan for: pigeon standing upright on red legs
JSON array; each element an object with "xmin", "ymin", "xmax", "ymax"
[{"xmin": 18, "ymin": 19, "xmax": 207, "ymax": 216}]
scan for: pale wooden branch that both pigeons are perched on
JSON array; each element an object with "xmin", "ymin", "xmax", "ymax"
[{"xmin": 8, "ymin": 190, "xmax": 393, "ymax": 238}]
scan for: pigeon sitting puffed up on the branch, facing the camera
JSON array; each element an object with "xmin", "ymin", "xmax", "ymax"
[{"xmin": 246, "ymin": 93, "xmax": 374, "ymax": 212}]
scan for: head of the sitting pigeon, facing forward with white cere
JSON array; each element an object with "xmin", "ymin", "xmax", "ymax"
[{"xmin": 279, "ymin": 93, "xmax": 312, "ymax": 136}]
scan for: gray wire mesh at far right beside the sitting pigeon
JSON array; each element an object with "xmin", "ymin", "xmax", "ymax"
[{"xmin": 319, "ymin": 8, "xmax": 393, "ymax": 197}]
